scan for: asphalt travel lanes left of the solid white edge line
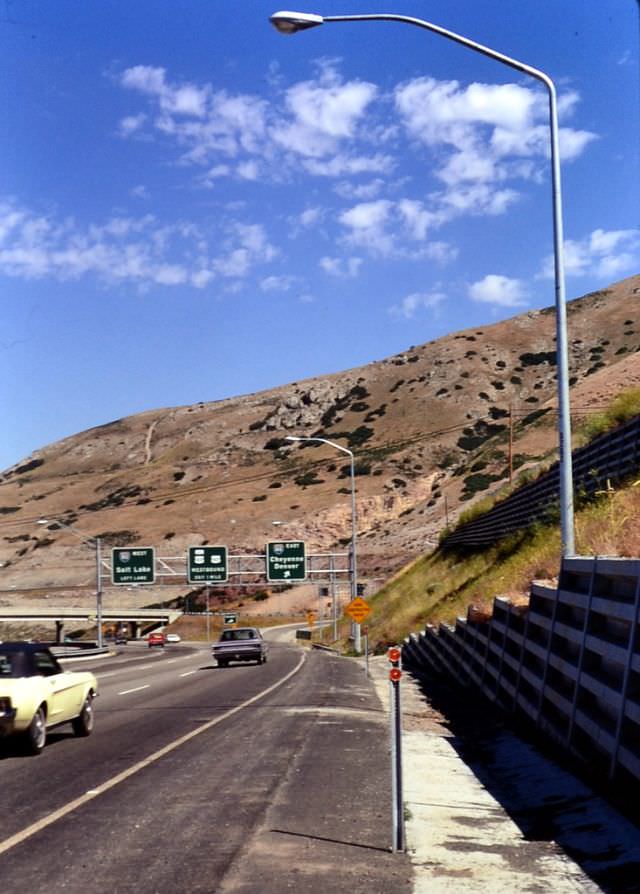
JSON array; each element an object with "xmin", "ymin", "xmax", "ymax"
[{"xmin": 0, "ymin": 644, "xmax": 299, "ymax": 841}]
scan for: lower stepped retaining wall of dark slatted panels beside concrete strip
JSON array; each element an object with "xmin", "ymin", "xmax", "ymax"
[{"xmin": 402, "ymin": 557, "xmax": 640, "ymax": 782}]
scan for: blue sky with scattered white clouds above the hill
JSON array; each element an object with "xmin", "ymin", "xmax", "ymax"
[{"xmin": 0, "ymin": 0, "xmax": 640, "ymax": 468}]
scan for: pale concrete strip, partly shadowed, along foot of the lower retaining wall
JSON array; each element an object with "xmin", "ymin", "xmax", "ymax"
[{"xmin": 371, "ymin": 658, "xmax": 640, "ymax": 894}]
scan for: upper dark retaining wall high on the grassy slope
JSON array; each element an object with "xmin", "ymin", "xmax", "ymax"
[{"xmin": 442, "ymin": 416, "xmax": 640, "ymax": 549}]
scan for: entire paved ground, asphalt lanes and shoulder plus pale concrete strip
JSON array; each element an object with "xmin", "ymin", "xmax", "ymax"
[{"xmin": 5, "ymin": 631, "xmax": 640, "ymax": 894}]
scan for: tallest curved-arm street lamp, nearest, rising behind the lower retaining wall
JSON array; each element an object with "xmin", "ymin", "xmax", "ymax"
[{"xmin": 270, "ymin": 12, "xmax": 575, "ymax": 557}]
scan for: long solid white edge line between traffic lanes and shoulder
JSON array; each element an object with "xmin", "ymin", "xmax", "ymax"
[{"xmin": 0, "ymin": 655, "xmax": 306, "ymax": 854}]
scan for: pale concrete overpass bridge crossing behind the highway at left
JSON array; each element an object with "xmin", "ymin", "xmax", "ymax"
[{"xmin": 0, "ymin": 605, "xmax": 182, "ymax": 642}]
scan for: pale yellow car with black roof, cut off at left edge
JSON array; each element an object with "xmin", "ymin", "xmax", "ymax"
[{"xmin": 0, "ymin": 642, "xmax": 98, "ymax": 754}]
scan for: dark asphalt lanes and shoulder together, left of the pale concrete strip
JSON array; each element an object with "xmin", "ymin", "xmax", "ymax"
[{"xmin": 0, "ymin": 644, "xmax": 410, "ymax": 894}]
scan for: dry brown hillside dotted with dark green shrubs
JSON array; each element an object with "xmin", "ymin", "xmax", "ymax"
[{"xmin": 0, "ymin": 276, "xmax": 640, "ymax": 593}]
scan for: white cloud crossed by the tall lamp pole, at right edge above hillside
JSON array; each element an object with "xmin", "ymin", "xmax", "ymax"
[{"xmin": 540, "ymin": 229, "xmax": 640, "ymax": 280}]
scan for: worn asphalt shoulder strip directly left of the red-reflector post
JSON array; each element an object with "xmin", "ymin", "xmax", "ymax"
[{"xmin": 220, "ymin": 652, "xmax": 412, "ymax": 894}]
